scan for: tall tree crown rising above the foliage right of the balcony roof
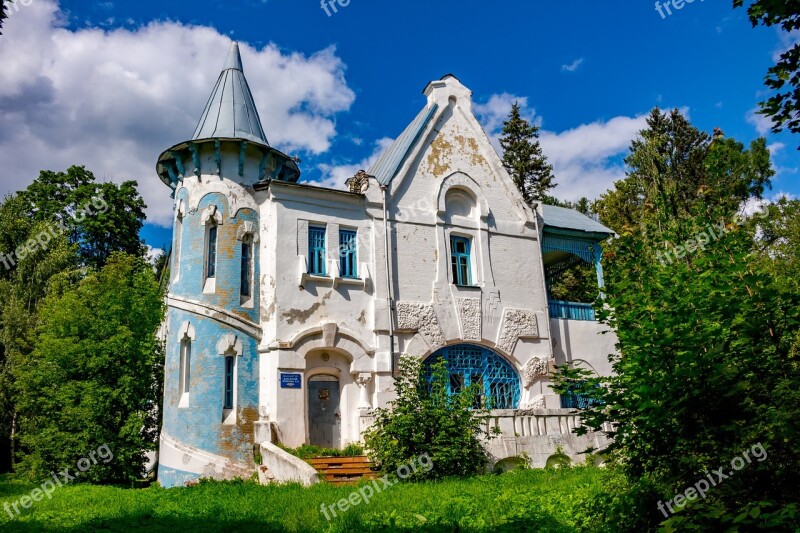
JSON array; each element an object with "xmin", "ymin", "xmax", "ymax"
[{"xmin": 592, "ymin": 109, "xmax": 774, "ymax": 235}]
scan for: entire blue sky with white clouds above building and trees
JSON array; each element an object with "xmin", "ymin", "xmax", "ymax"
[{"xmin": 0, "ymin": 0, "xmax": 800, "ymax": 247}]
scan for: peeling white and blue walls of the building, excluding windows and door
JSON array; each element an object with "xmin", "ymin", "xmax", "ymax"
[{"xmin": 159, "ymin": 77, "xmax": 610, "ymax": 486}]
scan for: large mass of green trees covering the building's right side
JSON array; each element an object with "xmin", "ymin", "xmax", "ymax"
[{"xmin": 556, "ymin": 113, "xmax": 800, "ymax": 530}]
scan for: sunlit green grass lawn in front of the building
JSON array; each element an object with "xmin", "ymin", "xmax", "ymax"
[{"xmin": 0, "ymin": 467, "xmax": 603, "ymax": 533}]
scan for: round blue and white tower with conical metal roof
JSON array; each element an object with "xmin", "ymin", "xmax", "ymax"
[{"xmin": 157, "ymin": 43, "xmax": 300, "ymax": 487}]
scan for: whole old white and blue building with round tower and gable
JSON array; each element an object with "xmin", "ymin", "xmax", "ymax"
[{"xmin": 158, "ymin": 44, "xmax": 616, "ymax": 486}]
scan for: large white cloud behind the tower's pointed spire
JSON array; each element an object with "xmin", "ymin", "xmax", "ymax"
[{"xmin": 0, "ymin": 0, "xmax": 355, "ymax": 224}]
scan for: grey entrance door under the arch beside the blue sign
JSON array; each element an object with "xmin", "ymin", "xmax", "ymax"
[{"xmin": 308, "ymin": 374, "xmax": 342, "ymax": 448}]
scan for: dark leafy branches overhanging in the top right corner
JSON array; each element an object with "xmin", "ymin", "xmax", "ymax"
[{"xmin": 733, "ymin": 0, "xmax": 800, "ymax": 140}]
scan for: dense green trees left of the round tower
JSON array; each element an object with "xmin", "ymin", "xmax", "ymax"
[{"xmin": 0, "ymin": 166, "xmax": 163, "ymax": 481}]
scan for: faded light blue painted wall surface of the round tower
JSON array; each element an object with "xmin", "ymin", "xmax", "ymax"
[{"xmin": 159, "ymin": 188, "xmax": 260, "ymax": 487}]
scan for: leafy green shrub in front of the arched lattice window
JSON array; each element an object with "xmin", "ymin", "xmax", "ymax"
[{"xmin": 365, "ymin": 357, "xmax": 487, "ymax": 481}]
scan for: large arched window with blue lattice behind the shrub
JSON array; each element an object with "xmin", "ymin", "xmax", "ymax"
[{"xmin": 423, "ymin": 344, "xmax": 520, "ymax": 409}]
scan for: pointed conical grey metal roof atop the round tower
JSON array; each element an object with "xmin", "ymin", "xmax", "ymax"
[{"xmin": 192, "ymin": 42, "xmax": 269, "ymax": 146}]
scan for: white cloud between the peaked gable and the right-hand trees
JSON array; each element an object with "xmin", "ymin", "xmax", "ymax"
[{"xmin": 473, "ymin": 93, "xmax": 648, "ymax": 200}]
